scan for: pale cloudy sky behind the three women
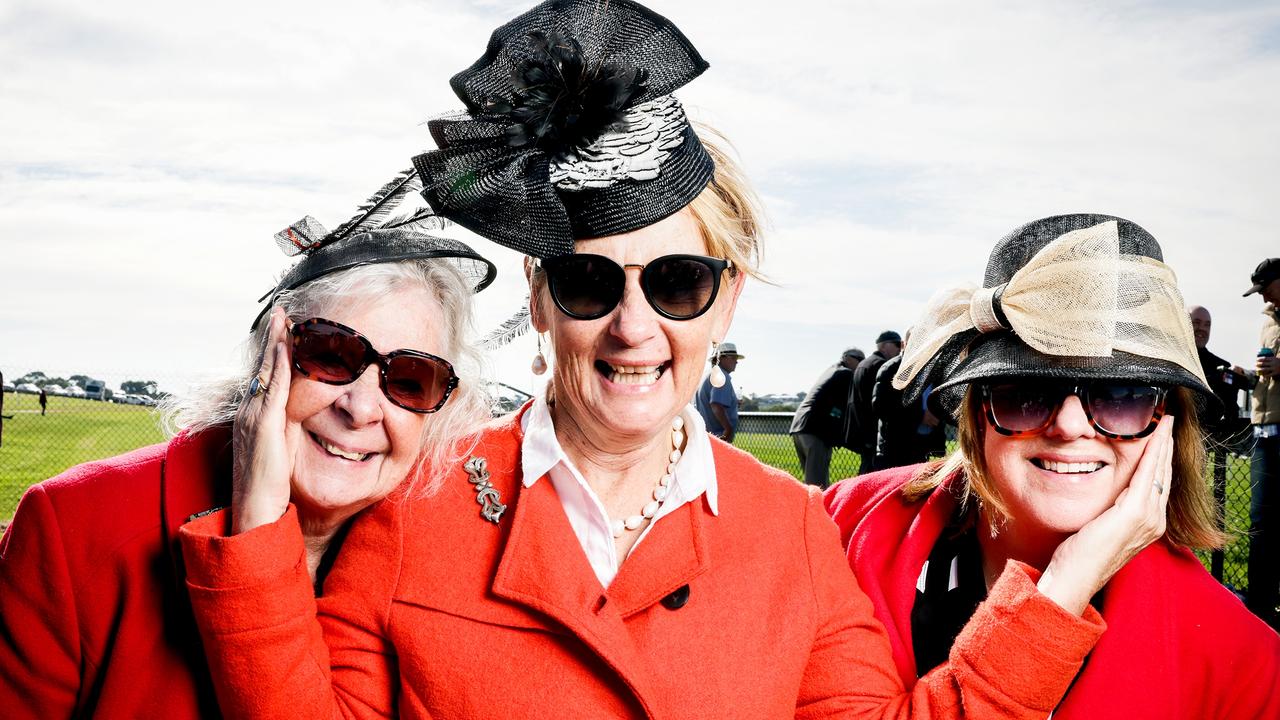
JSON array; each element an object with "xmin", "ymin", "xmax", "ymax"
[{"xmin": 0, "ymin": 0, "xmax": 1280, "ymax": 395}]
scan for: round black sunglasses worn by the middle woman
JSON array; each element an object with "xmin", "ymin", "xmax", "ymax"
[{"xmin": 539, "ymin": 254, "xmax": 733, "ymax": 320}]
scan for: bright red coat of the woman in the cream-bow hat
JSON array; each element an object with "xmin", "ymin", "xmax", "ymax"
[{"xmin": 826, "ymin": 465, "xmax": 1280, "ymax": 720}]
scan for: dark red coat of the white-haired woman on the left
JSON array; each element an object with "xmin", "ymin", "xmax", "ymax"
[{"xmin": 0, "ymin": 432, "xmax": 230, "ymax": 720}]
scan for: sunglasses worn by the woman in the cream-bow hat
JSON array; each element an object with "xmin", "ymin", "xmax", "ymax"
[{"xmin": 982, "ymin": 380, "xmax": 1167, "ymax": 439}]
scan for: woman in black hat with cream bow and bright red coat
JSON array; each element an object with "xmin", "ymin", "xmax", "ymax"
[{"xmin": 827, "ymin": 214, "xmax": 1280, "ymax": 720}]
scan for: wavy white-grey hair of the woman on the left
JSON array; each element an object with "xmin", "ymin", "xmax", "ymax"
[{"xmin": 161, "ymin": 259, "xmax": 490, "ymax": 495}]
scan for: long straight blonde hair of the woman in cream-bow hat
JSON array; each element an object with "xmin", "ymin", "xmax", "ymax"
[{"xmin": 902, "ymin": 384, "xmax": 1228, "ymax": 550}]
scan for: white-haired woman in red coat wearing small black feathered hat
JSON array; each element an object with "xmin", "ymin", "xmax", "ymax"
[{"xmin": 0, "ymin": 169, "xmax": 493, "ymax": 720}]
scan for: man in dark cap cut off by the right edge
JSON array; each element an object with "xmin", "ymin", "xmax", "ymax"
[{"xmin": 1244, "ymin": 258, "xmax": 1280, "ymax": 629}]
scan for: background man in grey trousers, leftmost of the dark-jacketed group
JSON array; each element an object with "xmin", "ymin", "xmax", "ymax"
[{"xmin": 791, "ymin": 347, "xmax": 867, "ymax": 488}]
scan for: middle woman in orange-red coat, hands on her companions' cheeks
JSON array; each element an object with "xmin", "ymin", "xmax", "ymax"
[{"xmin": 183, "ymin": 0, "xmax": 1177, "ymax": 720}]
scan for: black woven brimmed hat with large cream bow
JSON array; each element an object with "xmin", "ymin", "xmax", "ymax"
[{"xmin": 893, "ymin": 214, "xmax": 1217, "ymax": 418}]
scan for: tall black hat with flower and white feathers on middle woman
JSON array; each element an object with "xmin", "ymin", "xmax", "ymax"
[{"xmin": 413, "ymin": 0, "xmax": 716, "ymax": 258}]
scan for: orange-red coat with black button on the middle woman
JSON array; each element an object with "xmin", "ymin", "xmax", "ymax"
[{"xmin": 182, "ymin": 409, "xmax": 1101, "ymax": 720}]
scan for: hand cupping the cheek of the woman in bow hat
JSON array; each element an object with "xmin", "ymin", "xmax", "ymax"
[{"xmin": 1037, "ymin": 415, "xmax": 1174, "ymax": 615}]
